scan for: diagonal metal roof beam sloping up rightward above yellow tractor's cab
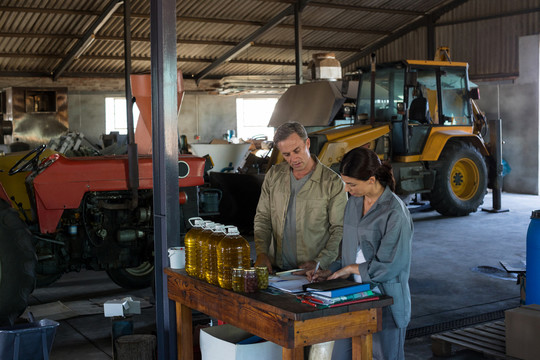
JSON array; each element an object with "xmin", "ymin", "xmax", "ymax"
[{"xmin": 341, "ymin": 0, "xmax": 469, "ymax": 67}]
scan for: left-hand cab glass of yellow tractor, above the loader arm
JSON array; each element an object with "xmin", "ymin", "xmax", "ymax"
[{"xmin": 359, "ymin": 68, "xmax": 404, "ymax": 121}]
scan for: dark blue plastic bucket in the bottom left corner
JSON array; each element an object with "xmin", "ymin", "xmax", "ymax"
[{"xmin": 0, "ymin": 319, "xmax": 60, "ymax": 360}]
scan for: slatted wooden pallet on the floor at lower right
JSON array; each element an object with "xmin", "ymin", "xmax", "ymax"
[{"xmin": 431, "ymin": 320, "xmax": 514, "ymax": 359}]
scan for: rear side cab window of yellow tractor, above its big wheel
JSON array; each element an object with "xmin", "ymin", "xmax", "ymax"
[{"xmin": 441, "ymin": 68, "xmax": 472, "ymax": 126}]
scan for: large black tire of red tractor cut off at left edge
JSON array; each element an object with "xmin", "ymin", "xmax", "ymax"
[{"xmin": 0, "ymin": 200, "xmax": 37, "ymax": 326}]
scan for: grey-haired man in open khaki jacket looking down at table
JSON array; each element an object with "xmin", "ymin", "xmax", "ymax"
[{"xmin": 254, "ymin": 122, "xmax": 347, "ymax": 272}]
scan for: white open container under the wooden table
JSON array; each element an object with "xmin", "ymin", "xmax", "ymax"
[{"xmin": 199, "ymin": 324, "xmax": 282, "ymax": 360}]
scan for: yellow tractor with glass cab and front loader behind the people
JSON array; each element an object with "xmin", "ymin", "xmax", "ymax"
[{"xmin": 270, "ymin": 49, "xmax": 491, "ymax": 216}]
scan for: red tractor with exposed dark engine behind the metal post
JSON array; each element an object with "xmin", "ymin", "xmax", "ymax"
[{"xmin": 0, "ymin": 145, "xmax": 205, "ymax": 324}]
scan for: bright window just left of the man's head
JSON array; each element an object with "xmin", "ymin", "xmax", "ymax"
[{"xmin": 236, "ymin": 97, "xmax": 278, "ymax": 140}]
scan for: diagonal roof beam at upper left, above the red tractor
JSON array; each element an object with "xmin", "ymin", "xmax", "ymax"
[{"xmin": 51, "ymin": 0, "xmax": 123, "ymax": 80}]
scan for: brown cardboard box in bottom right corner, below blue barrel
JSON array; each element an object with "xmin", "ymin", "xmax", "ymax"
[{"xmin": 504, "ymin": 304, "xmax": 540, "ymax": 360}]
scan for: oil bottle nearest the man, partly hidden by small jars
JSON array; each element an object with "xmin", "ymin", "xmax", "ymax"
[{"xmin": 216, "ymin": 226, "xmax": 250, "ymax": 289}]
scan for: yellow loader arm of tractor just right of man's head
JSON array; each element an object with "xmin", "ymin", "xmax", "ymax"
[{"xmin": 318, "ymin": 125, "xmax": 390, "ymax": 166}]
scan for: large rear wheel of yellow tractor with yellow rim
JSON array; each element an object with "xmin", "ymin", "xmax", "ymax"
[{"xmin": 430, "ymin": 141, "xmax": 487, "ymax": 216}]
